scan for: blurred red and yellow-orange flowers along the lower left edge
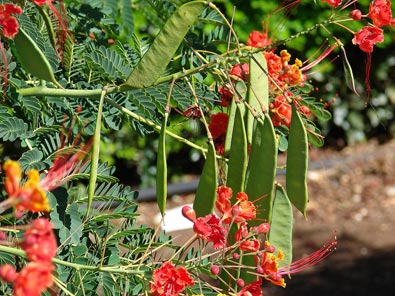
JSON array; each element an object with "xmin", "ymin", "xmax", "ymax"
[{"xmin": 0, "ymin": 138, "xmax": 91, "ymax": 296}]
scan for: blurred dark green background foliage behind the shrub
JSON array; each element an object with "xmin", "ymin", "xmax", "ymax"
[{"xmin": 0, "ymin": 0, "xmax": 395, "ymax": 188}]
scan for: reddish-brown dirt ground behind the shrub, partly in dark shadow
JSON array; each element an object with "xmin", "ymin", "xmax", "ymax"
[{"xmin": 139, "ymin": 140, "xmax": 395, "ymax": 296}]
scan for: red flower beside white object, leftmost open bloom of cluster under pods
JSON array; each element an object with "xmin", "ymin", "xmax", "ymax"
[{"xmin": 193, "ymin": 214, "xmax": 226, "ymax": 249}]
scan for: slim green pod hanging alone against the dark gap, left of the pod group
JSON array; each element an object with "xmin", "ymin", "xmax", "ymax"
[{"xmin": 156, "ymin": 112, "xmax": 169, "ymax": 216}]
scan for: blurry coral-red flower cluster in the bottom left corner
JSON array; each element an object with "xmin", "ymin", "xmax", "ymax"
[{"xmin": 0, "ymin": 218, "xmax": 57, "ymax": 296}]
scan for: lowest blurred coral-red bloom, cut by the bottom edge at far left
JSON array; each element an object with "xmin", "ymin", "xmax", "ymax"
[{"xmin": 14, "ymin": 262, "xmax": 55, "ymax": 296}]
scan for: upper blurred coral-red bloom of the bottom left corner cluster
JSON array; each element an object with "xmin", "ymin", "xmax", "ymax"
[{"xmin": 20, "ymin": 218, "xmax": 58, "ymax": 263}]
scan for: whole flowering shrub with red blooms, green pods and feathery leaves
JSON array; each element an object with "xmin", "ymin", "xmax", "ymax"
[{"xmin": 0, "ymin": 0, "xmax": 394, "ymax": 296}]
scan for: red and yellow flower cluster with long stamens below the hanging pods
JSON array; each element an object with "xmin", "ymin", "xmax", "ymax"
[{"xmin": 179, "ymin": 186, "xmax": 336, "ymax": 295}]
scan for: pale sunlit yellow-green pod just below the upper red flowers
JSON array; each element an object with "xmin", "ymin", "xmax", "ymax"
[{"xmin": 246, "ymin": 52, "xmax": 269, "ymax": 143}]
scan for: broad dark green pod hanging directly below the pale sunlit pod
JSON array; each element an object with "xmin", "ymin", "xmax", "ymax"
[{"xmin": 245, "ymin": 114, "xmax": 277, "ymax": 222}]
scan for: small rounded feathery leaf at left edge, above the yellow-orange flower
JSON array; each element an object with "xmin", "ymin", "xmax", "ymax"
[{"xmin": 0, "ymin": 117, "xmax": 33, "ymax": 142}]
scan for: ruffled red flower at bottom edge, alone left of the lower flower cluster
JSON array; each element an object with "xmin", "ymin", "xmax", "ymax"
[{"xmin": 150, "ymin": 261, "xmax": 194, "ymax": 296}]
